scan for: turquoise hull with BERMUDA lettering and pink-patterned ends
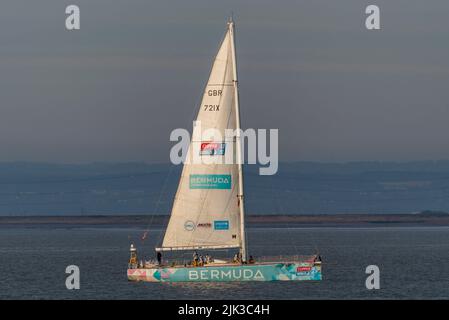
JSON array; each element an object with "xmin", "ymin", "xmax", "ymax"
[{"xmin": 128, "ymin": 262, "xmax": 321, "ymax": 282}]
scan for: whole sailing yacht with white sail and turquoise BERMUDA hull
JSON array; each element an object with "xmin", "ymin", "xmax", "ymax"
[{"xmin": 127, "ymin": 20, "xmax": 321, "ymax": 282}]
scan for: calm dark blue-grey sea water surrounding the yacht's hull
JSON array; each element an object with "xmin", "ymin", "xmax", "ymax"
[{"xmin": 0, "ymin": 227, "xmax": 449, "ymax": 299}]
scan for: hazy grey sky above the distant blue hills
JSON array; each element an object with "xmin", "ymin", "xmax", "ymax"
[{"xmin": 0, "ymin": 0, "xmax": 449, "ymax": 163}]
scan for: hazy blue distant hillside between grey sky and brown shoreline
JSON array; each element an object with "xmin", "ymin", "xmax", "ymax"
[{"xmin": 0, "ymin": 161, "xmax": 449, "ymax": 215}]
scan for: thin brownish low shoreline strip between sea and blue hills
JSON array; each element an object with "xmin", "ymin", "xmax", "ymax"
[{"xmin": 0, "ymin": 214, "xmax": 449, "ymax": 228}]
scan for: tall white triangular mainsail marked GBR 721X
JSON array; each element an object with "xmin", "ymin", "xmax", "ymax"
[{"xmin": 156, "ymin": 22, "xmax": 245, "ymax": 254}]
